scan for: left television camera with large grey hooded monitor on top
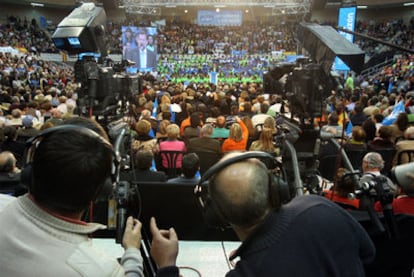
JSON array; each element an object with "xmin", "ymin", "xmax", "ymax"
[{"xmin": 52, "ymin": 3, "xmax": 142, "ymax": 116}]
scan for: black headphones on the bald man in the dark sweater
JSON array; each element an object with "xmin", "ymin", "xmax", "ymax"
[{"xmin": 194, "ymin": 151, "xmax": 291, "ymax": 229}]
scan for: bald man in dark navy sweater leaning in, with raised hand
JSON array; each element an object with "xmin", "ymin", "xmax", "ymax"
[{"xmin": 151, "ymin": 152, "xmax": 375, "ymax": 277}]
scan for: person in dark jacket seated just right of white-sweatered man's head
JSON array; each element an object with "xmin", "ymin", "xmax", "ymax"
[{"xmin": 126, "ymin": 150, "xmax": 167, "ymax": 182}]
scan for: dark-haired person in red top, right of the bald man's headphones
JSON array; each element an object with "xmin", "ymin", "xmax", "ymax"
[{"xmin": 323, "ymin": 167, "xmax": 359, "ymax": 209}]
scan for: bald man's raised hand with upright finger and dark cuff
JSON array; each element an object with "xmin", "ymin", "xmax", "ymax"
[{"xmin": 150, "ymin": 217, "xmax": 178, "ymax": 268}]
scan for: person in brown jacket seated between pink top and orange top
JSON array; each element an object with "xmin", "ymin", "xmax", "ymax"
[{"xmin": 187, "ymin": 124, "xmax": 221, "ymax": 153}]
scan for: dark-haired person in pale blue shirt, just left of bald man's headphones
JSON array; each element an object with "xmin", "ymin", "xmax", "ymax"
[{"xmin": 167, "ymin": 153, "xmax": 200, "ymax": 185}]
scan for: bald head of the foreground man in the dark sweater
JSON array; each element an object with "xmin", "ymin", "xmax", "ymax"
[{"xmin": 209, "ymin": 153, "xmax": 270, "ymax": 228}]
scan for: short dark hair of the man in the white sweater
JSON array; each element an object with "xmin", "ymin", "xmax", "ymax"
[{"xmin": 31, "ymin": 119, "xmax": 113, "ymax": 212}]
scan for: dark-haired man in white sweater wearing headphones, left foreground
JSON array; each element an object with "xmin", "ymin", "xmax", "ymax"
[{"xmin": 0, "ymin": 118, "xmax": 143, "ymax": 276}]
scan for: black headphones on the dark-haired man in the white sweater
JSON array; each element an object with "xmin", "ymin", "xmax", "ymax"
[{"xmin": 20, "ymin": 124, "xmax": 115, "ymax": 197}]
